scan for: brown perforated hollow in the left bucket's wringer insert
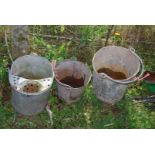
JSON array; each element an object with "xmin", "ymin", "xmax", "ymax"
[{"xmin": 23, "ymin": 83, "xmax": 40, "ymax": 93}]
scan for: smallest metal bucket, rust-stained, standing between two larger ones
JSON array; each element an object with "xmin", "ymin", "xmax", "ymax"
[{"xmin": 55, "ymin": 60, "xmax": 91, "ymax": 103}]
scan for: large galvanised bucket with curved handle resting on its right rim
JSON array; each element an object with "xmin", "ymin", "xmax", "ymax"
[{"xmin": 92, "ymin": 46, "xmax": 143, "ymax": 104}]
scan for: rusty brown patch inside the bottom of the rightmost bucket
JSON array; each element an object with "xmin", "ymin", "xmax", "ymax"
[{"xmin": 98, "ymin": 68, "xmax": 127, "ymax": 80}]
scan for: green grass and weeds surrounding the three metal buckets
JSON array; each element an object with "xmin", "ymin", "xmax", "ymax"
[{"xmin": 0, "ymin": 26, "xmax": 155, "ymax": 129}]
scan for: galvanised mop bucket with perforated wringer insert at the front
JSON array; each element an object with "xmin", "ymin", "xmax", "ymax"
[{"xmin": 9, "ymin": 55, "xmax": 54, "ymax": 115}]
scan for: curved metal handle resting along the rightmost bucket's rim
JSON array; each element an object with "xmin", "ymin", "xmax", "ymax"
[{"xmin": 98, "ymin": 47, "xmax": 144, "ymax": 84}]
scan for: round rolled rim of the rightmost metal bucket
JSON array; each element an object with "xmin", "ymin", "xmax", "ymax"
[{"xmin": 92, "ymin": 46, "xmax": 140, "ymax": 83}]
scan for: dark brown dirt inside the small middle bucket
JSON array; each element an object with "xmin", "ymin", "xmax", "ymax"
[{"xmin": 60, "ymin": 76, "xmax": 84, "ymax": 88}]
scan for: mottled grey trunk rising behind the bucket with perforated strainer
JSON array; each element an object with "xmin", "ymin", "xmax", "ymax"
[{"xmin": 11, "ymin": 25, "xmax": 28, "ymax": 59}]
